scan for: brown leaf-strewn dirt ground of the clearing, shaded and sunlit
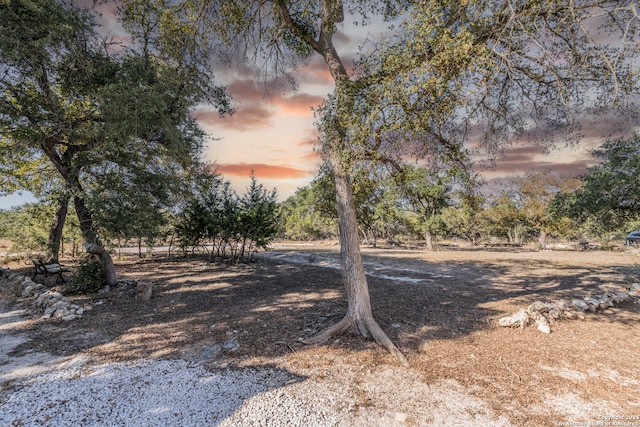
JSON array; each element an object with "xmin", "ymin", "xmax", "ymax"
[{"xmin": 1, "ymin": 242, "xmax": 640, "ymax": 426}]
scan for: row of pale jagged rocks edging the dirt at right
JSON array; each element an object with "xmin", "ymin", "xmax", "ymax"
[{"xmin": 498, "ymin": 283, "xmax": 640, "ymax": 334}]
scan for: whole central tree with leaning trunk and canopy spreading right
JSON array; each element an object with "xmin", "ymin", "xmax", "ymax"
[{"xmin": 123, "ymin": 0, "xmax": 640, "ymax": 362}]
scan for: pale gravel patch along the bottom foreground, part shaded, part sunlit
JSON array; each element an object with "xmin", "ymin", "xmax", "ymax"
[{"xmin": 0, "ymin": 360, "xmax": 510, "ymax": 427}]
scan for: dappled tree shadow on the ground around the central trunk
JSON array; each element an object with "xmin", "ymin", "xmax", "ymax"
[{"xmin": 6, "ymin": 251, "xmax": 638, "ymax": 366}]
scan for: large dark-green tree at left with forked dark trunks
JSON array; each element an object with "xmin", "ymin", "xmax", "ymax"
[{"xmin": 0, "ymin": 0, "xmax": 229, "ymax": 285}]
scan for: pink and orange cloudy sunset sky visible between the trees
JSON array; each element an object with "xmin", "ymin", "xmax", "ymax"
[{"xmin": 0, "ymin": 5, "xmax": 632, "ymax": 209}]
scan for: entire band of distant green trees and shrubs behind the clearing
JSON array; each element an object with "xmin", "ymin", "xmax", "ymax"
[{"xmin": 5, "ymin": 135, "xmax": 640, "ymax": 260}]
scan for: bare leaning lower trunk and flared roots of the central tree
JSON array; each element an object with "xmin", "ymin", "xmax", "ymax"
[{"xmin": 305, "ymin": 153, "xmax": 407, "ymax": 364}]
